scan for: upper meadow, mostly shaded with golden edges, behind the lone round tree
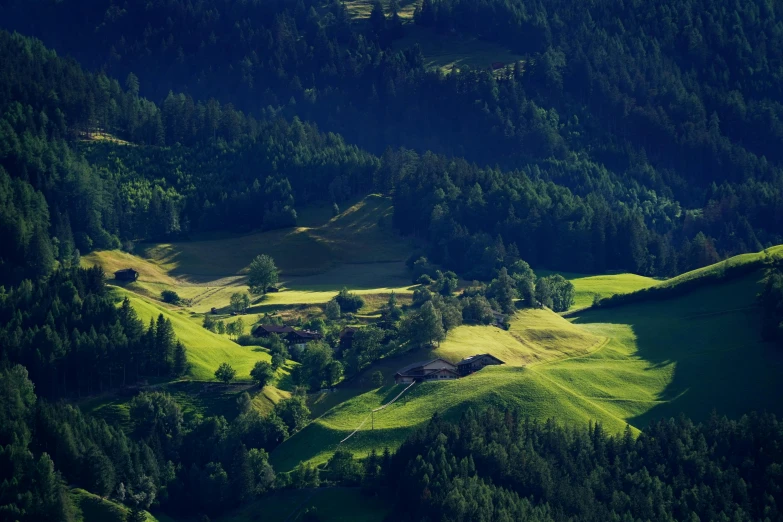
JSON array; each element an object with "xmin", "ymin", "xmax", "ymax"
[{"xmin": 82, "ymin": 196, "xmax": 412, "ymax": 313}]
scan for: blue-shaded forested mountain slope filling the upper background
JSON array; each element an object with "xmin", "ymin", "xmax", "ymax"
[{"xmin": 5, "ymin": 0, "xmax": 783, "ymax": 275}]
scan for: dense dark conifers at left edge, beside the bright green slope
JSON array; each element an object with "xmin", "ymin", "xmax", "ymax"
[{"xmin": 0, "ymin": 267, "xmax": 187, "ymax": 398}]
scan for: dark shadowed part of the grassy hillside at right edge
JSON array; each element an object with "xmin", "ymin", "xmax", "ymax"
[{"xmin": 574, "ymin": 273, "xmax": 783, "ymax": 429}]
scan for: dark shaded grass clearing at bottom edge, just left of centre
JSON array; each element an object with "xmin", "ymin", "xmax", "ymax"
[{"xmin": 218, "ymin": 488, "xmax": 388, "ymax": 522}]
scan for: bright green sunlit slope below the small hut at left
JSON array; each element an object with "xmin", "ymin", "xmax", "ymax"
[{"xmin": 116, "ymin": 288, "xmax": 271, "ymax": 379}]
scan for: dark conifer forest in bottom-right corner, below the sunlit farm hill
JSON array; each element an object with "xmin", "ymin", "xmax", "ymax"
[{"xmin": 382, "ymin": 408, "xmax": 783, "ymax": 522}]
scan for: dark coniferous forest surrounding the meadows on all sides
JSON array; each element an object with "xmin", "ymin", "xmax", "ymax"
[{"xmin": 0, "ymin": 0, "xmax": 783, "ymax": 522}]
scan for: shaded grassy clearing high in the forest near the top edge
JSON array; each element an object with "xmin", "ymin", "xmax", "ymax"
[{"xmin": 396, "ymin": 25, "xmax": 524, "ymax": 73}]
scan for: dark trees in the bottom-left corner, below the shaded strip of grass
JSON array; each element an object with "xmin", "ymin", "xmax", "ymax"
[{"xmin": 0, "ymin": 365, "xmax": 318, "ymax": 522}]
